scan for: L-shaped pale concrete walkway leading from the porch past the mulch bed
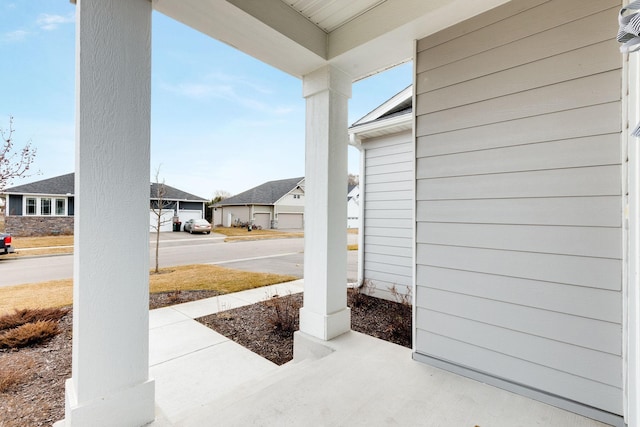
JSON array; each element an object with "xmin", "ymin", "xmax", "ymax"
[{"xmin": 149, "ymin": 280, "xmax": 302, "ymax": 426}]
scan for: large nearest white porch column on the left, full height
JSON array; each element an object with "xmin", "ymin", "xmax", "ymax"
[{"xmin": 64, "ymin": 0, "xmax": 155, "ymax": 426}]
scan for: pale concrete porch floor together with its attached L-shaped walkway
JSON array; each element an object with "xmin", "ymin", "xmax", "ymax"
[{"xmin": 150, "ymin": 280, "xmax": 606, "ymax": 427}]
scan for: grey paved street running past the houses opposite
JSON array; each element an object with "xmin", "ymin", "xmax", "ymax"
[{"xmin": 0, "ymin": 232, "xmax": 358, "ymax": 286}]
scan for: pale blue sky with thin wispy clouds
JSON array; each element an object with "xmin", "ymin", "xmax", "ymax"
[{"xmin": 0, "ymin": 0, "xmax": 411, "ymax": 198}]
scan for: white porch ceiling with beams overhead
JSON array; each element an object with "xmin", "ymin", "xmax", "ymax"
[{"xmin": 153, "ymin": 0, "xmax": 509, "ymax": 81}]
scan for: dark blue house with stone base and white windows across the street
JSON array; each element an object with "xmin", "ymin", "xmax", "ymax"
[{"xmin": 2, "ymin": 173, "xmax": 206, "ymax": 236}]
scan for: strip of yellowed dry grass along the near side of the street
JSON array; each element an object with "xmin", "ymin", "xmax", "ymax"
[{"xmin": 0, "ymin": 265, "xmax": 297, "ymax": 315}]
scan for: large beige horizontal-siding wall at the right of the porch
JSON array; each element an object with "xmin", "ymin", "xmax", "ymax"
[{"xmin": 415, "ymin": 0, "xmax": 624, "ymax": 421}]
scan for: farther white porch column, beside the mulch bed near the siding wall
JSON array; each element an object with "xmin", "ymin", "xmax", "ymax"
[{"xmin": 300, "ymin": 65, "xmax": 351, "ymax": 340}]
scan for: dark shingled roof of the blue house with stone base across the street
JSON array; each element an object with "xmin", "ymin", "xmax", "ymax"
[{"xmin": 4, "ymin": 173, "xmax": 206, "ymax": 202}]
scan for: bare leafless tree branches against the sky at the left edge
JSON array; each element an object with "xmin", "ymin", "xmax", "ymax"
[{"xmin": 0, "ymin": 116, "xmax": 36, "ymax": 191}]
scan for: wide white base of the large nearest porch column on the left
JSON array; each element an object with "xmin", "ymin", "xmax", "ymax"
[{"xmin": 54, "ymin": 379, "xmax": 155, "ymax": 427}]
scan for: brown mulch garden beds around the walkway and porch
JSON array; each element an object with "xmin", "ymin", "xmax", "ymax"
[{"xmin": 0, "ymin": 291, "xmax": 411, "ymax": 427}]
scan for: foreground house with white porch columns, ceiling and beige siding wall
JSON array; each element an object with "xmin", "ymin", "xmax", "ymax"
[{"xmin": 65, "ymin": 0, "xmax": 640, "ymax": 427}]
